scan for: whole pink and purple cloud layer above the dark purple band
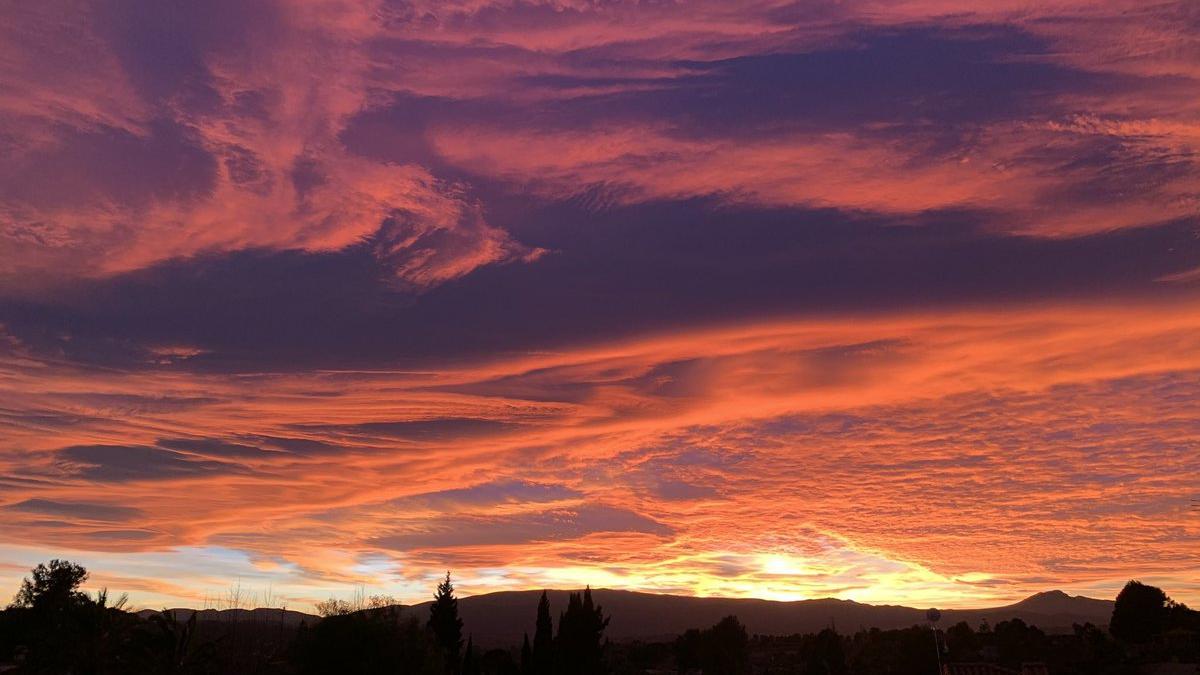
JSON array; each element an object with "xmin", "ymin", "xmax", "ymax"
[{"xmin": 9, "ymin": 1, "xmax": 1198, "ymax": 292}]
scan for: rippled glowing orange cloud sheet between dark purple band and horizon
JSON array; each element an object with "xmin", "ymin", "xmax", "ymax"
[{"xmin": 0, "ymin": 301, "xmax": 1200, "ymax": 604}]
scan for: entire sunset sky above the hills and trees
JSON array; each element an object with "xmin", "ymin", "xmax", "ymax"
[{"xmin": 0, "ymin": 0, "xmax": 1200, "ymax": 610}]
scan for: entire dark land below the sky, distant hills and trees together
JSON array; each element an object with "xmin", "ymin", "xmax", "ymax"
[{"xmin": 0, "ymin": 560, "xmax": 1200, "ymax": 675}]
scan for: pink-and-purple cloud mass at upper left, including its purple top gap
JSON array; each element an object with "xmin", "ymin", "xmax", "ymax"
[{"xmin": 0, "ymin": 4, "xmax": 536, "ymax": 289}]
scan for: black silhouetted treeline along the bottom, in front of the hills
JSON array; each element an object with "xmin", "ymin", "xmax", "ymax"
[{"xmin": 0, "ymin": 560, "xmax": 1200, "ymax": 675}]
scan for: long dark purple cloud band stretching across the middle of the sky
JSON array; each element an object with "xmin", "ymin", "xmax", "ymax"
[{"xmin": 9, "ymin": 201, "xmax": 1200, "ymax": 369}]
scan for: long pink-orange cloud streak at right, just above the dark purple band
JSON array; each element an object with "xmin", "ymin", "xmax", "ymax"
[{"xmin": 430, "ymin": 111, "xmax": 1200, "ymax": 237}]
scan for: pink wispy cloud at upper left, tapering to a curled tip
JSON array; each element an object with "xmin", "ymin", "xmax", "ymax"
[{"xmin": 0, "ymin": 0, "xmax": 535, "ymax": 286}]
